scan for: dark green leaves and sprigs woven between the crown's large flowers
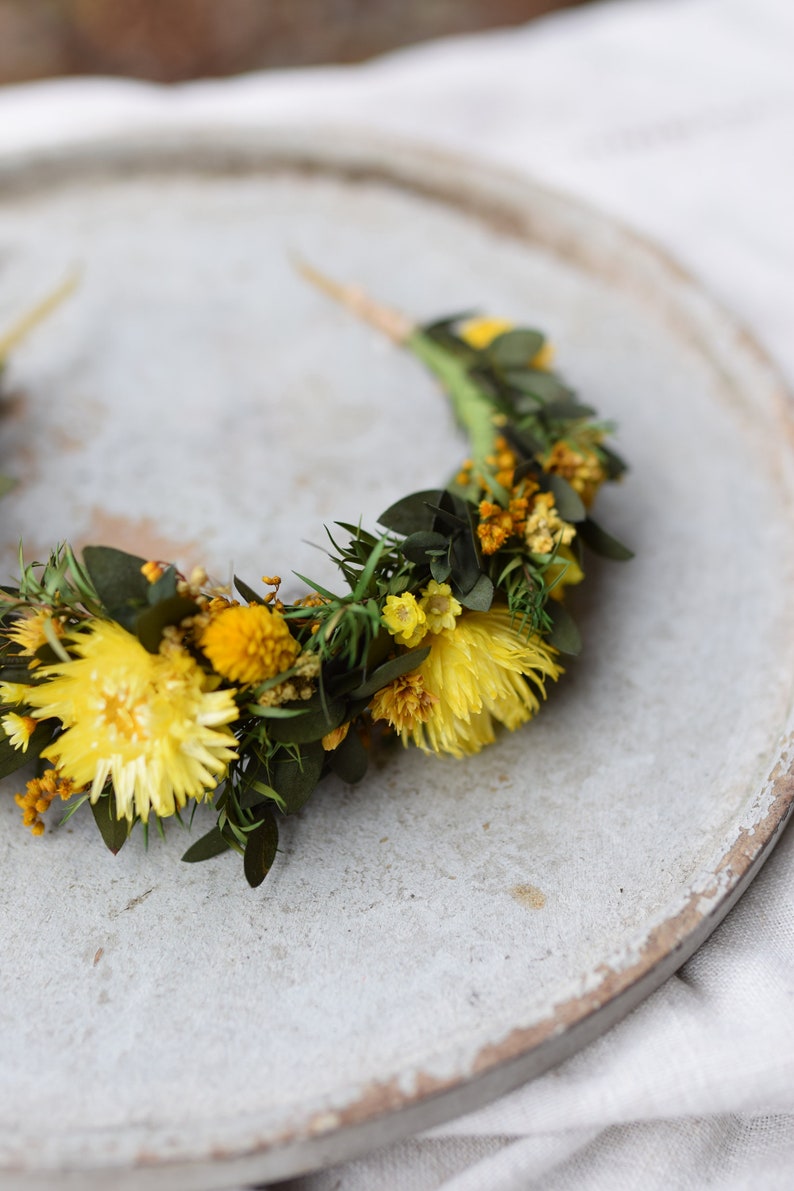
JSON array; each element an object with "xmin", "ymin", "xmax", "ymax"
[{"xmin": 0, "ymin": 292, "xmax": 632, "ymax": 887}]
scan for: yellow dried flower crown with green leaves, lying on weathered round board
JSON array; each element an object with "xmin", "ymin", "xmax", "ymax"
[{"xmin": 0, "ymin": 266, "xmax": 631, "ymax": 886}]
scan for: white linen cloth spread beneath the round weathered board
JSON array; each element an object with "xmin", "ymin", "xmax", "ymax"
[{"xmin": 0, "ymin": 0, "xmax": 794, "ymax": 1191}]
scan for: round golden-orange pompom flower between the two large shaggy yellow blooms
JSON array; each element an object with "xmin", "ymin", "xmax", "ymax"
[{"xmin": 199, "ymin": 604, "xmax": 300, "ymax": 686}]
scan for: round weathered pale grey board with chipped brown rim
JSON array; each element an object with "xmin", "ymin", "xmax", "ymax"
[{"xmin": 0, "ymin": 131, "xmax": 794, "ymax": 1189}]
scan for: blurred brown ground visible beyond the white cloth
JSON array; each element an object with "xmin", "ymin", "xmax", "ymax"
[{"xmin": 0, "ymin": 0, "xmax": 583, "ymax": 83}]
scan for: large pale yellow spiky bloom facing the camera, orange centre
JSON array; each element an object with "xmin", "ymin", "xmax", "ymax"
[{"xmin": 26, "ymin": 621, "xmax": 238, "ymax": 823}]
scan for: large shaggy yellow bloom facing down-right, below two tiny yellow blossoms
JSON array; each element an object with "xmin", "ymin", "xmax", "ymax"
[{"xmin": 383, "ymin": 607, "xmax": 562, "ymax": 757}]
